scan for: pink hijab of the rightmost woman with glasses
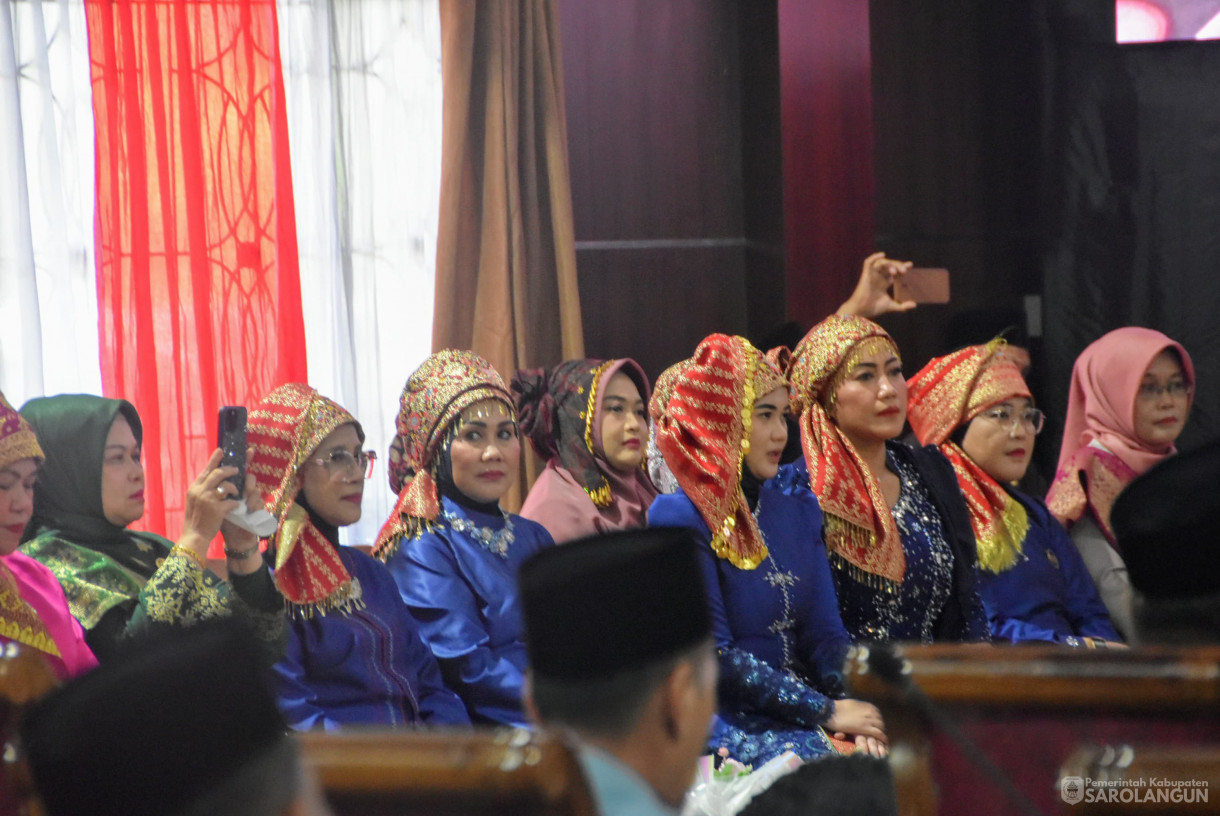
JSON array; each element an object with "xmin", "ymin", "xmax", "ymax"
[{"xmin": 1047, "ymin": 326, "xmax": 1194, "ymax": 540}]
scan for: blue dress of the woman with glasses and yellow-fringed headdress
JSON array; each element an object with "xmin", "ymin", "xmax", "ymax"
[{"xmin": 978, "ymin": 489, "xmax": 1122, "ymax": 646}]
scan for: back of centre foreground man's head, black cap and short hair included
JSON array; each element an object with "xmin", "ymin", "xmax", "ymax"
[{"xmin": 519, "ymin": 528, "xmax": 711, "ymax": 737}]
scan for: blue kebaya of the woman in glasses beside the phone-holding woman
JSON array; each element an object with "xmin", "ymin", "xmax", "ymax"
[{"xmin": 275, "ymin": 546, "xmax": 470, "ymax": 729}]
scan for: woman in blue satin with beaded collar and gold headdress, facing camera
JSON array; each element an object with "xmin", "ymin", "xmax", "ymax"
[{"xmin": 376, "ymin": 349, "xmax": 553, "ymax": 726}]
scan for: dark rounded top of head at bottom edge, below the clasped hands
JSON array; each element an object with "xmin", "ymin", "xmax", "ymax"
[{"xmin": 741, "ymin": 754, "xmax": 898, "ymax": 816}]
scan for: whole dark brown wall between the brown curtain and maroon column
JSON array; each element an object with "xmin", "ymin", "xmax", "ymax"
[{"xmin": 560, "ymin": 0, "xmax": 783, "ymax": 378}]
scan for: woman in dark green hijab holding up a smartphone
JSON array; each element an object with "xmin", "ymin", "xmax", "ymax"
[{"xmin": 21, "ymin": 394, "xmax": 285, "ymax": 662}]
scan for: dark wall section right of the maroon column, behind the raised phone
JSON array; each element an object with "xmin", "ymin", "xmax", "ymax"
[{"xmin": 870, "ymin": 0, "xmax": 1042, "ymax": 373}]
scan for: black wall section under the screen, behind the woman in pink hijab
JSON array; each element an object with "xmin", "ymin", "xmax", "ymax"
[{"xmin": 1046, "ymin": 0, "xmax": 1220, "ymax": 448}]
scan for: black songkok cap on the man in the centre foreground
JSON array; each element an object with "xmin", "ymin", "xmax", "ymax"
[{"xmin": 519, "ymin": 527, "xmax": 711, "ymax": 681}]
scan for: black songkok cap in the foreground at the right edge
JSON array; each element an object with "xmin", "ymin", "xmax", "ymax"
[{"xmin": 1110, "ymin": 443, "xmax": 1220, "ymax": 599}]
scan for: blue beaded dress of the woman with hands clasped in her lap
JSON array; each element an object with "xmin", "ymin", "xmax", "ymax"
[{"xmin": 648, "ymin": 485, "xmax": 849, "ymax": 766}]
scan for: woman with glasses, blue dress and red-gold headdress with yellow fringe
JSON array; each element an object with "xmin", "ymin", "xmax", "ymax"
[{"xmin": 906, "ymin": 340, "xmax": 1120, "ymax": 646}]
